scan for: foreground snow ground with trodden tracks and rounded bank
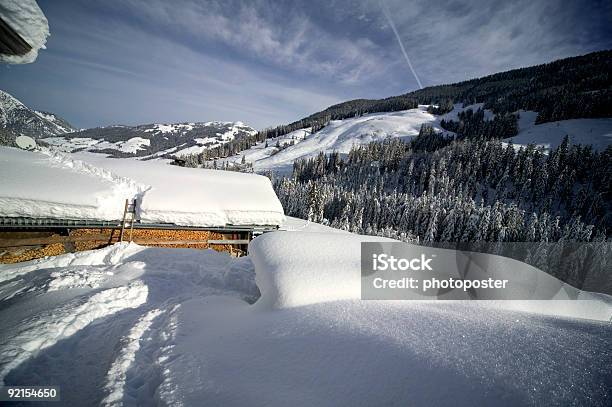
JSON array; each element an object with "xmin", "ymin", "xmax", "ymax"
[{"xmin": 0, "ymin": 231, "xmax": 612, "ymax": 406}]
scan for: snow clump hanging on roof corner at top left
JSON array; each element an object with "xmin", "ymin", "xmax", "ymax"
[{"xmin": 0, "ymin": 0, "xmax": 49, "ymax": 64}]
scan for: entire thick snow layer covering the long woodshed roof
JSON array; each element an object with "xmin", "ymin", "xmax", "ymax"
[{"xmin": 0, "ymin": 147, "xmax": 284, "ymax": 226}]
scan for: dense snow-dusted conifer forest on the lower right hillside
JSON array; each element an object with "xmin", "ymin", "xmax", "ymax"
[{"xmin": 274, "ymin": 139, "xmax": 612, "ymax": 287}]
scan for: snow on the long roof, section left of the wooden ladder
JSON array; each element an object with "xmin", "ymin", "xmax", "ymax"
[{"xmin": 0, "ymin": 147, "xmax": 144, "ymax": 220}]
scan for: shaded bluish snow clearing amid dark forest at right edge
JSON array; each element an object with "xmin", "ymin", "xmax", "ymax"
[{"xmin": 508, "ymin": 111, "xmax": 612, "ymax": 150}]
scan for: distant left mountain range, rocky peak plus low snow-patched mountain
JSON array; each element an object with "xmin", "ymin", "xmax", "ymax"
[{"xmin": 0, "ymin": 90, "xmax": 257, "ymax": 157}]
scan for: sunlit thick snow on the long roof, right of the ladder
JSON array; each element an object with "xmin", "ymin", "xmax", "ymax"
[{"xmin": 76, "ymin": 153, "xmax": 284, "ymax": 226}]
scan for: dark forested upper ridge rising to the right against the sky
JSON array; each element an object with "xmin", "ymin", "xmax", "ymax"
[{"xmin": 183, "ymin": 50, "xmax": 612, "ymax": 164}]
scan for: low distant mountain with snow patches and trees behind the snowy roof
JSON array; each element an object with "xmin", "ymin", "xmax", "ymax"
[{"xmin": 44, "ymin": 122, "xmax": 257, "ymax": 158}]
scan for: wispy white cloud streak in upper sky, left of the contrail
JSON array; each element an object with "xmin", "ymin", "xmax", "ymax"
[{"xmin": 112, "ymin": 0, "xmax": 385, "ymax": 83}]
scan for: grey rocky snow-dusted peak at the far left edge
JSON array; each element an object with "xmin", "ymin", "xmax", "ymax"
[{"xmin": 0, "ymin": 90, "xmax": 75, "ymax": 139}]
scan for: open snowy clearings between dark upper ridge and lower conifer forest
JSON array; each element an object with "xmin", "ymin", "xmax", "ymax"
[{"xmin": 217, "ymin": 103, "xmax": 612, "ymax": 173}]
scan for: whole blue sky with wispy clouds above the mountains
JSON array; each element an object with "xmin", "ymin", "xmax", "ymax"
[{"xmin": 0, "ymin": 0, "xmax": 612, "ymax": 128}]
